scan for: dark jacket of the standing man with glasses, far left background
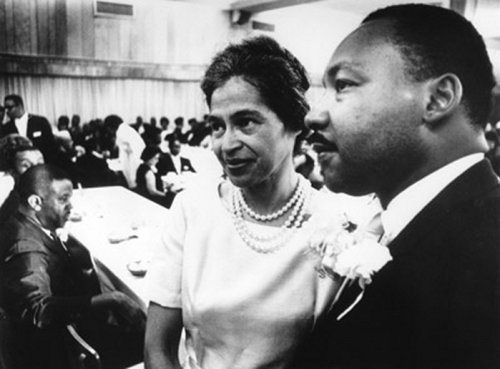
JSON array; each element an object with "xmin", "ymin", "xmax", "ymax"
[{"xmin": 1, "ymin": 114, "xmax": 57, "ymax": 162}]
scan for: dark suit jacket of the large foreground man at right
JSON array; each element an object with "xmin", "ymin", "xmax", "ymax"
[{"xmin": 295, "ymin": 161, "xmax": 500, "ymax": 369}]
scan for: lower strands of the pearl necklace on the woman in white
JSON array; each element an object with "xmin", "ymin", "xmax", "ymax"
[{"xmin": 231, "ymin": 177, "xmax": 311, "ymax": 254}]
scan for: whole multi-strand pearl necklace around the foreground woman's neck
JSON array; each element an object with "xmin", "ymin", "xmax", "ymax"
[{"xmin": 231, "ymin": 176, "xmax": 311, "ymax": 254}]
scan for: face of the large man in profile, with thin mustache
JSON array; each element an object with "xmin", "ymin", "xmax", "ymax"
[{"xmin": 306, "ymin": 21, "xmax": 425, "ymax": 195}]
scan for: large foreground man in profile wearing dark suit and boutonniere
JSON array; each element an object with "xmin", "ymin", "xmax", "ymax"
[{"xmin": 296, "ymin": 5, "xmax": 500, "ymax": 369}]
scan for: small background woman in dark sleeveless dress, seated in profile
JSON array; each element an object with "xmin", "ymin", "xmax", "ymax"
[{"xmin": 136, "ymin": 146, "xmax": 165, "ymax": 203}]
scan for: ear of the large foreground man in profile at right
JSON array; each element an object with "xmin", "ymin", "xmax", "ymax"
[{"xmin": 423, "ymin": 73, "xmax": 463, "ymax": 126}]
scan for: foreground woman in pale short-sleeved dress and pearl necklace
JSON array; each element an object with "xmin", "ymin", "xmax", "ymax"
[{"xmin": 145, "ymin": 37, "xmax": 337, "ymax": 368}]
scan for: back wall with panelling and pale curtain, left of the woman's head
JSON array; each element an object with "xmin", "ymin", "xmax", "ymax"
[{"xmin": 0, "ymin": 0, "xmax": 232, "ymax": 122}]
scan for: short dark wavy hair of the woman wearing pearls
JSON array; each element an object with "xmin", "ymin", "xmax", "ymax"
[{"xmin": 201, "ymin": 36, "xmax": 310, "ymax": 131}]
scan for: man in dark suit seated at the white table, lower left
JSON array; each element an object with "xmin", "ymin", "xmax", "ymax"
[{"xmin": 0, "ymin": 165, "xmax": 145, "ymax": 368}]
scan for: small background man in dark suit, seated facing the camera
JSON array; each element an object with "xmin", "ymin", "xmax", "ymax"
[{"xmin": 156, "ymin": 137, "xmax": 196, "ymax": 208}]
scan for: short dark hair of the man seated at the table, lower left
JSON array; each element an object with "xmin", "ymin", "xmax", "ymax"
[{"xmin": 15, "ymin": 164, "xmax": 71, "ymax": 202}]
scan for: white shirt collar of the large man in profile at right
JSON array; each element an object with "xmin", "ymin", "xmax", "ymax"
[{"xmin": 382, "ymin": 153, "xmax": 484, "ymax": 240}]
